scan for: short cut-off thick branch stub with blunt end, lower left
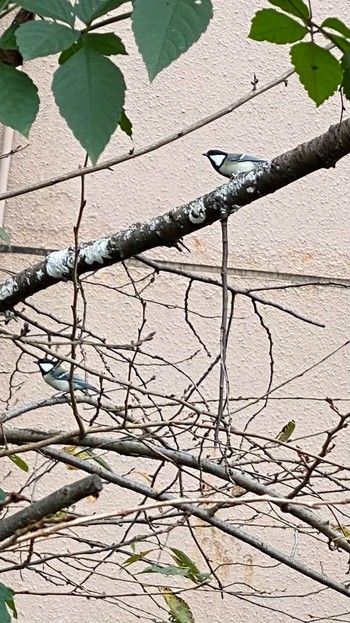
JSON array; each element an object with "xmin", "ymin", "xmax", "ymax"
[{"xmin": 0, "ymin": 474, "xmax": 102, "ymax": 541}]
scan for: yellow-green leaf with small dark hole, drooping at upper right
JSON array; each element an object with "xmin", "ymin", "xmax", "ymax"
[{"xmin": 290, "ymin": 41, "xmax": 342, "ymax": 106}]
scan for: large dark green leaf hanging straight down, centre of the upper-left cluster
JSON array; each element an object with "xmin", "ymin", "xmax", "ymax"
[{"xmin": 52, "ymin": 46, "xmax": 125, "ymax": 164}]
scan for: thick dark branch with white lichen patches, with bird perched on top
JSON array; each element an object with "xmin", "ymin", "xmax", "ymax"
[{"xmin": 0, "ymin": 119, "xmax": 350, "ymax": 311}]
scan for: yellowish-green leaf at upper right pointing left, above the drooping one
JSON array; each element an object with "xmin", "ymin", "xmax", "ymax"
[{"xmin": 248, "ymin": 9, "xmax": 307, "ymax": 44}]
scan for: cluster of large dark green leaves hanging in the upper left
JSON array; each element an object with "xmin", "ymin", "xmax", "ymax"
[{"xmin": 0, "ymin": 0, "xmax": 212, "ymax": 163}]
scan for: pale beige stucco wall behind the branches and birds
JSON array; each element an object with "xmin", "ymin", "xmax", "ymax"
[{"xmin": 0, "ymin": 0, "xmax": 350, "ymax": 623}]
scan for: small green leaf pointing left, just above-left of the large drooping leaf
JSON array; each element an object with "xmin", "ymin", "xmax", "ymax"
[{"xmin": 16, "ymin": 20, "xmax": 80, "ymax": 61}]
